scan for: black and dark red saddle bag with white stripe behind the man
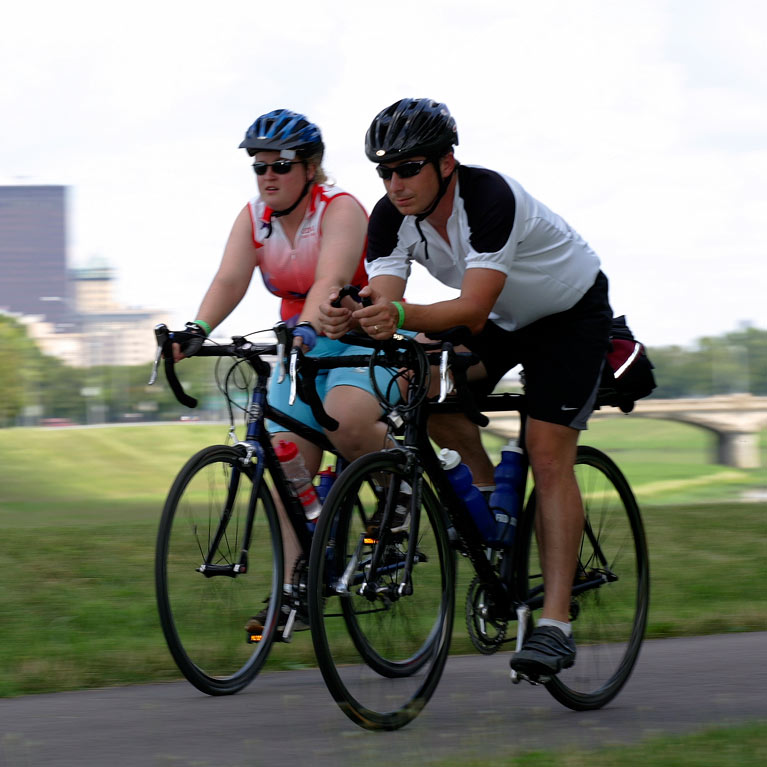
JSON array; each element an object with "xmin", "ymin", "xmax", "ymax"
[{"xmin": 602, "ymin": 315, "xmax": 657, "ymax": 413}]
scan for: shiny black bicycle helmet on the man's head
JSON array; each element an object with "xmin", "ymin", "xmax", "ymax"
[{"xmin": 365, "ymin": 99, "xmax": 458, "ymax": 163}]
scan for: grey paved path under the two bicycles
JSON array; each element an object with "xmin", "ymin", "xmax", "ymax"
[{"xmin": 0, "ymin": 632, "xmax": 767, "ymax": 767}]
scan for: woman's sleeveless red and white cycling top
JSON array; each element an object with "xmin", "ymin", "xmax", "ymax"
[{"xmin": 248, "ymin": 184, "xmax": 367, "ymax": 326}]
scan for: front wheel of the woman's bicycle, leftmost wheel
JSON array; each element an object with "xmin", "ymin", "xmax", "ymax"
[{"xmin": 155, "ymin": 445, "xmax": 283, "ymax": 695}]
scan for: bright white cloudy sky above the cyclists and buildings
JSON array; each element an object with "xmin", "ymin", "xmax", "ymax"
[{"xmin": 0, "ymin": 0, "xmax": 767, "ymax": 346}]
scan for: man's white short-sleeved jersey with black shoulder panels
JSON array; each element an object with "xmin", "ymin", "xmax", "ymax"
[{"xmin": 366, "ymin": 165, "xmax": 600, "ymax": 330}]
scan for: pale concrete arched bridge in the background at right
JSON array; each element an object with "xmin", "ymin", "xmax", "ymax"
[{"xmin": 486, "ymin": 394, "xmax": 767, "ymax": 469}]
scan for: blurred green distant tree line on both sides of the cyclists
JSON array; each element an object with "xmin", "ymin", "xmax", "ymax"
[{"xmin": 0, "ymin": 314, "xmax": 767, "ymax": 426}]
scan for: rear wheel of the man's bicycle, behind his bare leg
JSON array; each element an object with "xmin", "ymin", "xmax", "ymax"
[{"xmin": 520, "ymin": 446, "xmax": 650, "ymax": 711}]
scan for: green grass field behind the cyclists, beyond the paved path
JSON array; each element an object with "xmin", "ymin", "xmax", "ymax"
[{"xmin": 0, "ymin": 419, "xmax": 767, "ymax": 696}]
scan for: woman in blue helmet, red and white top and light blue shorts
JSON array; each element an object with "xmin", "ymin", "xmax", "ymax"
[{"xmin": 176, "ymin": 109, "xmax": 386, "ymax": 630}]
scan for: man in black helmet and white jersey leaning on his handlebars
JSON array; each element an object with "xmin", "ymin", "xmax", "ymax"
[{"xmin": 320, "ymin": 99, "xmax": 612, "ymax": 677}]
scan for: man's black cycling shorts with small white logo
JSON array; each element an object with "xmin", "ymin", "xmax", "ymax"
[{"xmin": 466, "ymin": 272, "xmax": 613, "ymax": 429}]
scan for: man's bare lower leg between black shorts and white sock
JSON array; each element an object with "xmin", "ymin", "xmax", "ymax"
[{"xmin": 527, "ymin": 418, "xmax": 583, "ymax": 623}]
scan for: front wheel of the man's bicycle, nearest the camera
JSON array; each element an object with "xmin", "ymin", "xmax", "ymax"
[{"xmin": 309, "ymin": 451, "xmax": 455, "ymax": 730}]
